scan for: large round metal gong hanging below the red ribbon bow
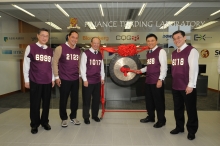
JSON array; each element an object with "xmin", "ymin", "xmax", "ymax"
[{"xmin": 109, "ymin": 55, "xmax": 142, "ymax": 86}]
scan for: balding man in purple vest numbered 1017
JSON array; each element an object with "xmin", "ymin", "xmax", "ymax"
[{"xmin": 80, "ymin": 37, "xmax": 105, "ymax": 124}]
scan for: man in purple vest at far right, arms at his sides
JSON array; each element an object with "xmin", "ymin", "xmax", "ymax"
[{"xmin": 170, "ymin": 30, "xmax": 199, "ymax": 140}]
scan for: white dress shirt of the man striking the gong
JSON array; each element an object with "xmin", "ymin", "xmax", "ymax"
[{"xmin": 141, "ymin": 45, "xmax": 167, "ymax": 80}]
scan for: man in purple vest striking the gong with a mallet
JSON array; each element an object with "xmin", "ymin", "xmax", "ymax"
[{"xmin": 137, "ymin": 34, "xmax": 167, "ymax": 128}]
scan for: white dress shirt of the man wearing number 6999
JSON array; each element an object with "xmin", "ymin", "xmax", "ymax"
[{"xmin": 23, "ymin": 42, "xmax": 54, "ymax": 83}]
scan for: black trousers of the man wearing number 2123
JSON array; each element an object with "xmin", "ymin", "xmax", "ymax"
[{"xmin": 59, "ymin": 79, "xmax": 79, "ymax": 120}]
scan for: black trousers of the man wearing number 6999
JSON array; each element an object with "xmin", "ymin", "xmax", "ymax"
[{"xmin": 30, "ymin": 81, "xmax": 52, "ymax": 127}]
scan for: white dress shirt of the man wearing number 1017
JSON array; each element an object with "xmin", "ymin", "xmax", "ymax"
[{"xmin": 80, "ymin": 48, "xmax": 105, "ymax": 81}]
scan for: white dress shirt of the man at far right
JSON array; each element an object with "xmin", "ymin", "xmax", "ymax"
[{"xmin": 171, "ymin": 43, "xmax": 199, "ymax": 88}]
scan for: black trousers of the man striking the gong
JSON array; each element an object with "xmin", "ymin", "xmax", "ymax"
[{"xmin": 145, "ymin": 83, "xmax": 166, "ymax": 123}]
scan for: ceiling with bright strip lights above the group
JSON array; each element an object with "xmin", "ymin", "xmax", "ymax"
[{"xmin": 0, "ymin": 2, "xmax": 220, "ymax": 32}]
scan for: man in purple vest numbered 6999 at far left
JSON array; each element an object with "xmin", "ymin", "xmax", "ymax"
[{"xmin": 23, "ymin": 28, "xmax": 54, "ymax": 134}]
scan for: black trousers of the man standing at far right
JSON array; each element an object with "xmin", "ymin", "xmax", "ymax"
[{"xmin": 172, "ymin": 88, "xmax": 198, "ymax": 134}]
